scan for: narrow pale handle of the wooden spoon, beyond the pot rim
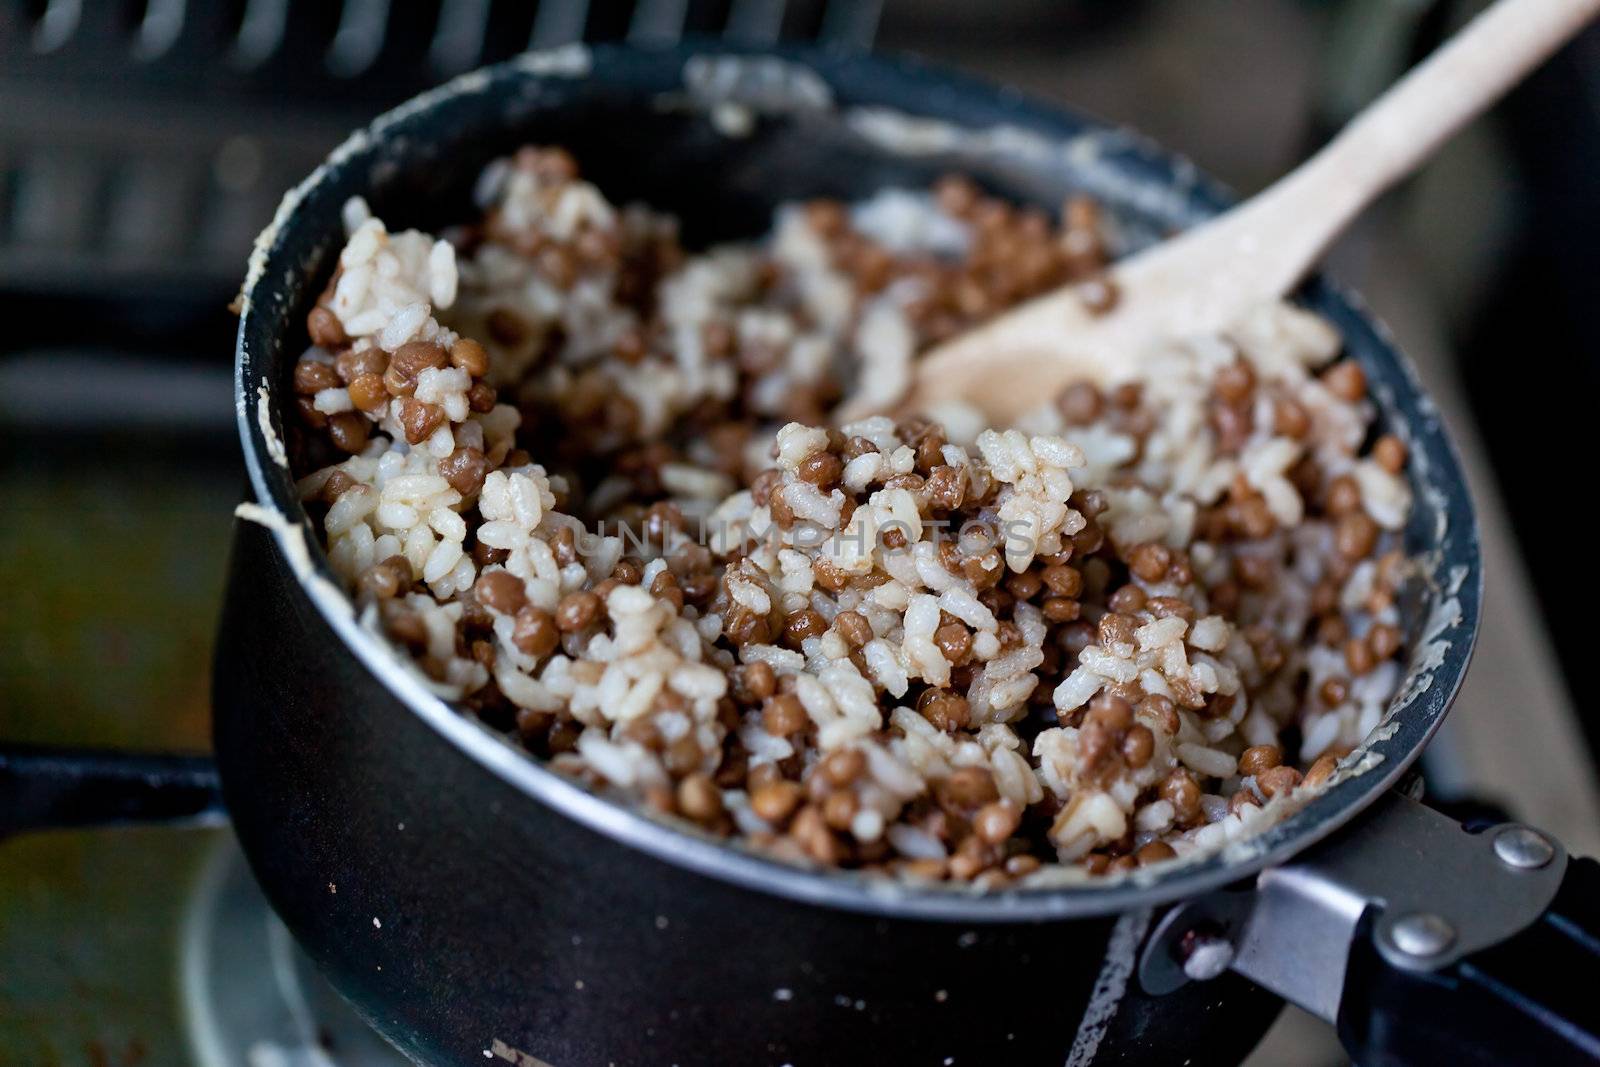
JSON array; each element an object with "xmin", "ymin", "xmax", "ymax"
[{"xmin": 1238, "ymin": 0, "xmax": 1600, "ymax": 287}]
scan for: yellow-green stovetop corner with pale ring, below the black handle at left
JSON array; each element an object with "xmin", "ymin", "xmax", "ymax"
[{"xmin": 0, "ymin": 829, "xmax": 406, "ymax": 1067}]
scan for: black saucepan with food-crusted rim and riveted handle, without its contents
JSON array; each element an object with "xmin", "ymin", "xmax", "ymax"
[{"xmin": 0, "ymin": 45, "xmax": 1600, "ymax": 1067}]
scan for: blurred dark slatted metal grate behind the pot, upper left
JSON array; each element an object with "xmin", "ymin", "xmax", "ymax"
[{"xmin": 0, "ymin": 0, "xmax": 880, "ymax": 313}]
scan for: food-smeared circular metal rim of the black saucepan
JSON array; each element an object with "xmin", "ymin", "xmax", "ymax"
[{"xmin": 234, "ymin": 42, "xmax": 1483, "ymax": 925}]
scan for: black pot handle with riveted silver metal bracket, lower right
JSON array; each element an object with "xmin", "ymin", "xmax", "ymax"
[{"xmin": 1139, "ymin": 793, "xmax": 1600, "ymax": 1067}]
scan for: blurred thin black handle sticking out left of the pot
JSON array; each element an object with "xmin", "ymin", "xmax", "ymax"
[{"xmin": 0, "ymin": 745, "xmax": 226, "ymax": 838}]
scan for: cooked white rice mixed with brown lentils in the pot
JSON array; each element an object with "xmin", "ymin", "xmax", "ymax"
[{"xmin": 291, "ymin": 147, "xmax": 1410, "ymax": 888}]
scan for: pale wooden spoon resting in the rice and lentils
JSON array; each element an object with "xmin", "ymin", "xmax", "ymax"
[{"xmin": 904, "ymin": 0, "xmax": 1600, "ymax": 422}]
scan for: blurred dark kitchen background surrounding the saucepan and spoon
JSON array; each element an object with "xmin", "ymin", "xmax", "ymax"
[{"xmin": 0, "ymin": 0, "xmax": 1600, "ymax": 1067}]
